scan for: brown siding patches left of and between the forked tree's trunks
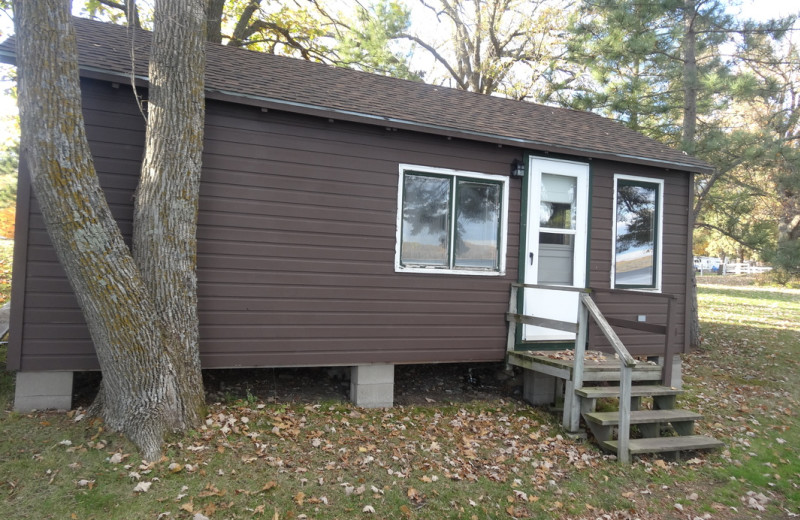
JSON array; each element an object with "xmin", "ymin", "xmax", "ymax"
[{"xmin": 12, "ymin": 82, "xmax": 144, "ymax": 370}]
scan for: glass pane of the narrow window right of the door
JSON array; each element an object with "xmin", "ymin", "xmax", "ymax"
[{"xmin": 614, "ymin": 181, "xmax": 658, "ymax": 287}]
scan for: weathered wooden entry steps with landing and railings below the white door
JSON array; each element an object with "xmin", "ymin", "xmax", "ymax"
[{"xmin": 506, "ymin": 284, "xmax": 723, "ymax": 463}]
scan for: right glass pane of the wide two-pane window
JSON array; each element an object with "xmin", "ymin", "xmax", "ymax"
[{"xmin": 455, "ymin": 180, "xmax": 500, "ymax": 269}]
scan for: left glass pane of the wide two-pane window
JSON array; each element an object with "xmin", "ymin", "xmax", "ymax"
[{"xmin": 400, "ymin": 174, "xmax": 450, "ymax": 266}]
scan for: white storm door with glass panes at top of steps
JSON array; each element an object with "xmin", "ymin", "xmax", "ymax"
[{"xmin": 522, "ymin": 157, "xmax": 589, "ymax": 342}]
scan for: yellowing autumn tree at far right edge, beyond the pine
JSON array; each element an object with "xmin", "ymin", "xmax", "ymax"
[{"xmin": 698, "ymin": 27, "xmax": 800, "ymax": 276}]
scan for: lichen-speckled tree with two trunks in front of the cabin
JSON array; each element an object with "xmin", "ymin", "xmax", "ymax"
[{"xmin": 14, "ymin": 0, "xmax": 206, "ymax": 460}]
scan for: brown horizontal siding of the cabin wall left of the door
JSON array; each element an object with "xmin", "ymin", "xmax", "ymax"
[{"xmin": 21, "ymin": 77, "xmax": 521, "ymax": 370}]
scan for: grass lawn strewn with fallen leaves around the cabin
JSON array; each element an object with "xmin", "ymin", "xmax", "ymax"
[{"xmin": 0, "ymin": 285, "xmax": 800, "ymax": 520}]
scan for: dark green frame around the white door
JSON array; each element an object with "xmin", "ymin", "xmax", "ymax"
[{"xmin": 514, "ymin": 153, "xmax": 594, "ymax": 350}]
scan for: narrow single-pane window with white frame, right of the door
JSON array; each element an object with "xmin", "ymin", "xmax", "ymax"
[{"xmin": 611, "ymin": 174, "xmax": 664, "ymax": 291}]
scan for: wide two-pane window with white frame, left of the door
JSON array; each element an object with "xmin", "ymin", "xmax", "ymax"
[{"xmin": 395, "ymin": 164, "xmax": 508, "ymax": 276}]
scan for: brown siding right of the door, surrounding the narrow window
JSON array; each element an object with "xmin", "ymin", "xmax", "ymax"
[{"xmin": 589, "ymin": 161, "xmax": 691, "ymax": 355}]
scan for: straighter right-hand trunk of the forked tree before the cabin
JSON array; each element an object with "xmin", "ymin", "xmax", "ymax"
[{"xmin": 133, "ymin": 0, "xmax": 206, "ymax": 426}]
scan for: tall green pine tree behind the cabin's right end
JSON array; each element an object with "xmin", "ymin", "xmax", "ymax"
[{"xmin": 568, "ymin": 0, "xmax": 794, "ymax": 345}]
